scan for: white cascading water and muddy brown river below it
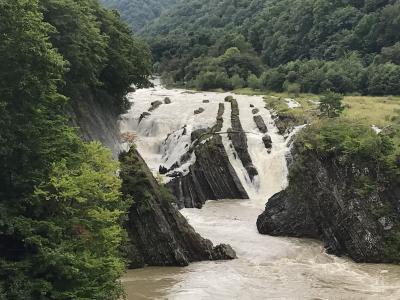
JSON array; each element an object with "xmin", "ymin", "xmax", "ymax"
[{"xmin": 122, "ymin": 81, "xmax": 400, "ymax": 300}]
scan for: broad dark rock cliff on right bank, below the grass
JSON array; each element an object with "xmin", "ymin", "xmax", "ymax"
[{"xmin": 257, "ymin": 142, "xmax": 400, "ymax": 263}]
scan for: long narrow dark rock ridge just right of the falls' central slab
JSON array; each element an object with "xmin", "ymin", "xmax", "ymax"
[{"xmin": 229, "ymin": 98, "xmax": 258, "ymax": 180}]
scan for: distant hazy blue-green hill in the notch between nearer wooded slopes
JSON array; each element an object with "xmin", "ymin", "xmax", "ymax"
[{"xmin": 100, "ymin": 0, "xmax": 177, "ymax": 31}]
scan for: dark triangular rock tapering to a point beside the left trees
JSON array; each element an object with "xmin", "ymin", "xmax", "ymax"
[{"xmin": 120, "ymin": 148, "xmax": 236, "ymax": 268}]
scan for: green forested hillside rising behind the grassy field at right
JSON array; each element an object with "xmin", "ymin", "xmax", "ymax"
[{"xmin": 144, "ymin": 0, "xmax": 400, "ymax": 95}]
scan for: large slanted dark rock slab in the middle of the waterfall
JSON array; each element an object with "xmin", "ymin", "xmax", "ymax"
[{"xmin": 167, "ymin": 103, "xmax": 249, "ymax": 208}]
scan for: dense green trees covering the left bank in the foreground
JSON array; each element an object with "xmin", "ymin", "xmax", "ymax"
[{"xmin": 0, "ymin": 0, "xmax": 150, "ymax": 300}]
